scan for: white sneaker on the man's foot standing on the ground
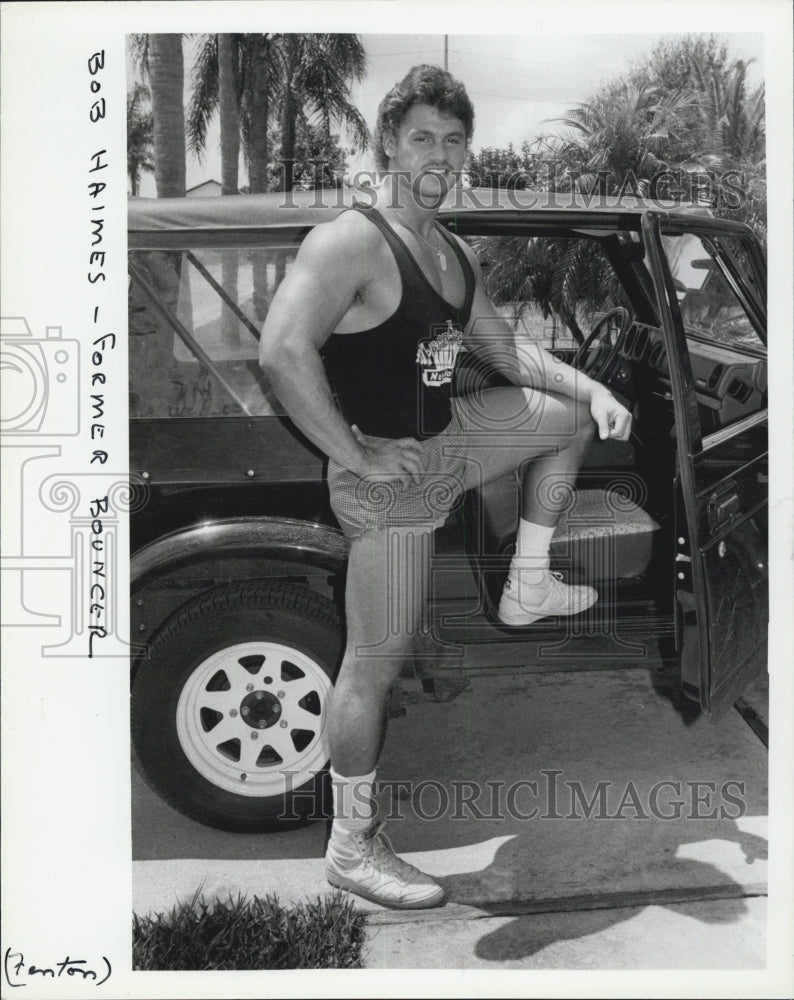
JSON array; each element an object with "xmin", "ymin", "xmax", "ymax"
[{"xmin": 325, "ymin": 823, "xmax": 444, "ymax": 910}]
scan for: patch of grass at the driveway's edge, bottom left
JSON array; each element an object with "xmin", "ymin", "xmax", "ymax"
[{"xmin": 132, "ymin": 892, "xmax": 364, "ymax": 971}]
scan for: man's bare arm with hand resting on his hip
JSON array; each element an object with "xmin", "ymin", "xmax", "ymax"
[{"xmin": 259, "ymin": 222, "xmax": 421, "ymax": 482}]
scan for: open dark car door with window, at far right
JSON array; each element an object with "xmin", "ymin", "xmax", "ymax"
[{"xmin": 642, "ymin": 212, "xmax": 768, "ymax": 718}]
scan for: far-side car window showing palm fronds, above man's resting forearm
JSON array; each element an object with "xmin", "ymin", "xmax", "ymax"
[{"xmin": 467, "ymin": 236, "xmax": 619, "ymax": 350}]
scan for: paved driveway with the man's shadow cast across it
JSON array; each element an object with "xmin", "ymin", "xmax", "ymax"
[{"xmin": 133, "ymin": 669, "xmax": 767, "ymax": 968}]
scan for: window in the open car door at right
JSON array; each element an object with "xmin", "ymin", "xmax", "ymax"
[{"xmin": 662, "ymin": 233, "xmax": 766, "ymax": 355}]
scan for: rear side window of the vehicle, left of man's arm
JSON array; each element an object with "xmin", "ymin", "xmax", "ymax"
[{"xmin": 129, "ymin": 246, "xmax": 297, "ymax": 418}]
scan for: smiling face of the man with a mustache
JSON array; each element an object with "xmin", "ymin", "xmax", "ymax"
[{"xmin": 383, "ymin": 104, "xmax": 466, "ymax": 203}]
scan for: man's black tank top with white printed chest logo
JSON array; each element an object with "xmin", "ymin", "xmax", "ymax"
[{"xmin": 321, "ymin": 205, "xmax": 474, "ymax": 440}]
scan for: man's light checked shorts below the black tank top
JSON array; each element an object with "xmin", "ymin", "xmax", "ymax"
[{"xmin": 328, "ymin": 398, "xmax": 470, "ymax": 538}]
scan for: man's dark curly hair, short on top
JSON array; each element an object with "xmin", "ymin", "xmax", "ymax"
[{"xmin": 372, "ymin": 65, "xmax": 474, "ymax": 170}]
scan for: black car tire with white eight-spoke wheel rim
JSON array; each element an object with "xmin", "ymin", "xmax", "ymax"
[{"xmin": 131, "ymin": 581, "xmax": 342, "ymax": 832}]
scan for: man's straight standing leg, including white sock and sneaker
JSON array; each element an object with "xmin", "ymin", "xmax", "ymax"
[{"xmin": 326, "ymin": 529, "xmax": 444, "ymax": 908}]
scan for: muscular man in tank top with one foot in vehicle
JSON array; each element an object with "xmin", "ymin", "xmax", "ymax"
[{"xmin": 260, "ymin": 66, "xmax": 631, "ymax": 907}]
